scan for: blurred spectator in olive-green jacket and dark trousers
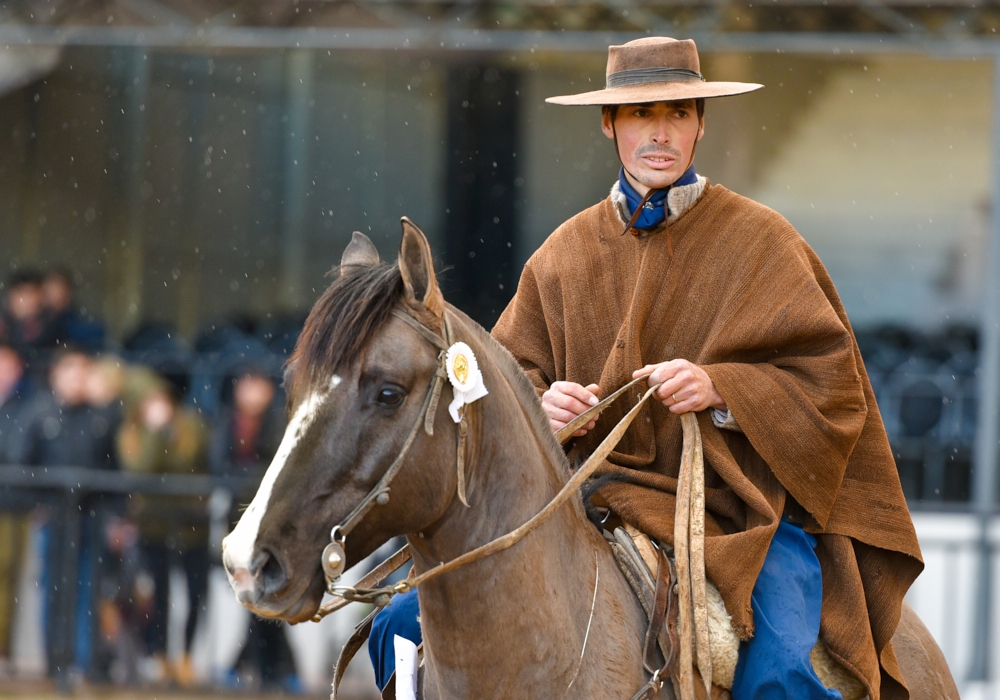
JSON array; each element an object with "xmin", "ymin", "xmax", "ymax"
[{"xmin": 117, "ymin": 381, "xmax": 209, "ymax": 685}]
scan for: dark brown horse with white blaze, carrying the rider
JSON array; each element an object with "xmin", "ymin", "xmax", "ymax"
[{"xmin": 223, "ymin": 219, "xmax": 958, "ymax": 699}]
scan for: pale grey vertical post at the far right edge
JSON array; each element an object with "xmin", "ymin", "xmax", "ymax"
[{"xmin": 969, "ymin": 54, "xmax": 1000, "ymax": 681}]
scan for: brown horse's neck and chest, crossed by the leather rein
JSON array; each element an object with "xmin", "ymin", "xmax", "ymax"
[{"xmin": 402, "ymin": 342, "xmax": 614, "ymax": 697}]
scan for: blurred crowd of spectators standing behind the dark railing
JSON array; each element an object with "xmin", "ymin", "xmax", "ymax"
[{"xmin": 0, "ymin": 270, "xmax": 298, "ymax": 690}]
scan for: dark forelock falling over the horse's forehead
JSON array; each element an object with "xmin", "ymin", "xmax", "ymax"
[{"xmin": 288, "ymin": 263, "xmax": 403, "ymax": 400}]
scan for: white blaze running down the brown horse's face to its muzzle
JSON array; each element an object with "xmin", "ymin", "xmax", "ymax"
[{"xmin": 222, "ymin": 375, "xmax": 341, "ymax": 596}]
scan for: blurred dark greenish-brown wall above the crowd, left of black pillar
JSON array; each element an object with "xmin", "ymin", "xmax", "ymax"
[{"xmin": 0, "ymin": 49, "xmax": 444, "ymax": 336}]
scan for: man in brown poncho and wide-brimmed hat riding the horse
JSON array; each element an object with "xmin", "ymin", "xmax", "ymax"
[{"xmin": 369, "ymin": 37, "xmax": 923, "ymax": 700}]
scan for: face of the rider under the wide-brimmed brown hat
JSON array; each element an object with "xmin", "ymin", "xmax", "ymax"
[{"xmin": 601, "ymin": 100, "xmax": 705, "ymax": 195}]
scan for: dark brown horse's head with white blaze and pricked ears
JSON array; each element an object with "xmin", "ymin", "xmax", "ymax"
[{"xmin": 222, "ymin": 218, "xmax": 457, "ymax": 622}]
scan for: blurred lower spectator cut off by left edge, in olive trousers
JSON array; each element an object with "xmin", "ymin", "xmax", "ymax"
[{"xmin": 0, "ymin": 342, "xmax": 32, "ymax": 660}]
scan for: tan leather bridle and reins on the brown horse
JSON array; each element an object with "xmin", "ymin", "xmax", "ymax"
[{"xmin": 313, "ymin": 309, "xmax": 712, "ymax": 700}]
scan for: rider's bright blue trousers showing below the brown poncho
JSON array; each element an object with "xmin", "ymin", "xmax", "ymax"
[{"xmin": 368, "ymin": 520, "xmax": 842, "ymax": 700}]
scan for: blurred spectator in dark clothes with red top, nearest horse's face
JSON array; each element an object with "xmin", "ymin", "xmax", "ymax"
[{"xmin": 205, "ymin": 367, "xmax": 298, "ymax": 690}]
